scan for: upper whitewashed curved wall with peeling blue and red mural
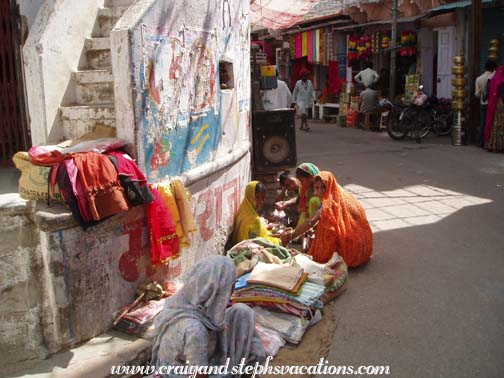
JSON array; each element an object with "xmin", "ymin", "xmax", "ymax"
[{"xmin": 111, "ymin": 0, "xmax": 250, "ymax": 182}]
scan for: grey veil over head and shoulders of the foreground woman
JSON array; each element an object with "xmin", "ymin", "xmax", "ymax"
[{"xmin": 151, "ymin": 256, "xmax": 236, "ymax": 363}]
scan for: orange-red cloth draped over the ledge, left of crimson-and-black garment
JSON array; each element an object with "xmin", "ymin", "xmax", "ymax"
[{"xmin": 74, "ymin": 152, "xmax": 128, "ymax": 220}]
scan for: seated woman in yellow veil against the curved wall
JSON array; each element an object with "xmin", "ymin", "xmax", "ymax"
[{"xmin": 232, "ymin": 181, "xmax": 280, "ymax": 245}]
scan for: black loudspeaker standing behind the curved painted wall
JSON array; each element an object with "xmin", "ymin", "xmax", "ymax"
[{"xmin": 252, "ymin": 109, "xmax": 297, "ymax": 172}]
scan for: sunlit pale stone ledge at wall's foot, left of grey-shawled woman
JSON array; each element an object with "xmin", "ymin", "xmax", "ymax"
[{"xmin": 12, "ymin": 331, "xmax": 151, "ymax": 378}]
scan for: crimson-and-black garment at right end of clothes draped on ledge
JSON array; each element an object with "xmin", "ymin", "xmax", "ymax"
[{"xmin": 107, "ymin": 151, "xmax": 154, "ymax": 206}]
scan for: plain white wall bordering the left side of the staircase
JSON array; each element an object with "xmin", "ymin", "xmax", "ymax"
[{"xmin": 23, "ymin": 0, "xmax": 103, "ymax": 145}]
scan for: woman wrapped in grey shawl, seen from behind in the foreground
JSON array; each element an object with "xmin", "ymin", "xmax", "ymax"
[{"xmin": 151, "ymin": 256, "xmax": 265, "ymax": 377}]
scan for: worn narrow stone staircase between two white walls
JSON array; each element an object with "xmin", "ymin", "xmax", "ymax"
[{"xmin": 60, "ymin": 0, "xmax": 134, "ymax": 139}]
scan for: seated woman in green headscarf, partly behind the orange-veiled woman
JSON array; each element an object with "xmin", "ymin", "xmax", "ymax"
[{"xmin": 296, "ymin": 163, "xmax": 320, "ymax": 226}]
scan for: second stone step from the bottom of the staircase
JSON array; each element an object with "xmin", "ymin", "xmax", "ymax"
[{"xmin": 72, "ymin": 70, "xmax": 114, "ymax": 105}]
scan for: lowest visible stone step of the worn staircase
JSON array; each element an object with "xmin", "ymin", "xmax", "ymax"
[{"xmin": 60, "ymin": 105, "xmax": 116, "ymax": 139}]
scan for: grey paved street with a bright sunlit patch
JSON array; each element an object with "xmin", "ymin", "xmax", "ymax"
[{"xmin": 297, "ymin": 122, "xmax": 504, "ymax": 378}]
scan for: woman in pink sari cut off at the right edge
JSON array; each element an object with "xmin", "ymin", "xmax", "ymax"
[{"xmin": 484, "ymin": 66, "xmax": 504, "ymax": 152}]
